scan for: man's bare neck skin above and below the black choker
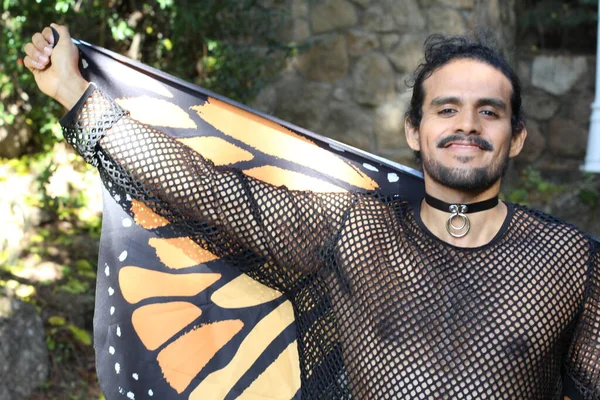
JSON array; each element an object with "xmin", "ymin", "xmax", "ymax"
[{"xmin": 421, "ymin": 181, "xmax": 508, "ymax": 247}]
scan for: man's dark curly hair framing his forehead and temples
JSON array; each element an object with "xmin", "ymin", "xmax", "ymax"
[{"xmin": 406, "ymin": 31, "xmax": 524, "ymax": 135}]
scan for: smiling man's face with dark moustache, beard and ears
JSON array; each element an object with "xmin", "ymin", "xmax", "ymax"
[{"xmin": 406, "ymin": 59, "xmax": 527, "ymax": 192}]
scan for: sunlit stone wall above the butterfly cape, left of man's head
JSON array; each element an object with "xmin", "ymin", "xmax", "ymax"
[{"xmin": 254, "ymin": 0, "xmax": 515, "ymax": 165}]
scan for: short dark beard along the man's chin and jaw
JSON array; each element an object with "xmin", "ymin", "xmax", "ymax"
[{"xmin": 422, "ymin": 146, "xmax": 510, "ymax": 192}]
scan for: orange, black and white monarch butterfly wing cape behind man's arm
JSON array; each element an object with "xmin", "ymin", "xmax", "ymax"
[{"xmin": 74, "ymin": 40, "xmax": 423, "ymax": 400}]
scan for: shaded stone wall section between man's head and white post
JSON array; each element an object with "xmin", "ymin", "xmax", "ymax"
[{"xmin": 517, "ymin": 53, "xmax": 596, "ymax": 172}]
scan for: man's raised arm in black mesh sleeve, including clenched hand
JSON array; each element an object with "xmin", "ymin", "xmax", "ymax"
[{"xmin": 25, "ymin": 25, "xmax": 357, "ymax": 292}]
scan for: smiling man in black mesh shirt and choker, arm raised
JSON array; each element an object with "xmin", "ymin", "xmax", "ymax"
[{"xmin": 25, "ymin": 25, "xmax": 600, "ymax": 399}]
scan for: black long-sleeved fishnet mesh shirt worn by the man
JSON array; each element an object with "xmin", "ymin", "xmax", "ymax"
[{"xmin": 62, "ymin": 86, "xmax": 600, "ymax": 399}]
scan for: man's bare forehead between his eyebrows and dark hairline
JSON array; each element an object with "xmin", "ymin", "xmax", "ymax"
[{"xmin": 423, "ymin": 59, "xmax": 512, "ymax": 105}]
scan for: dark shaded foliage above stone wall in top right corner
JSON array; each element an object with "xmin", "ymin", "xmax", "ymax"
[{"xmin": 517, "ymin": 0, "xmax": 598, "ymax": 53}]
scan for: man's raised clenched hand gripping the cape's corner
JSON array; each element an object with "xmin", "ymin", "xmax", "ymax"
[{"xmin": 23, "ymin": 24, "xmax": 88, "ymax": 109}]
